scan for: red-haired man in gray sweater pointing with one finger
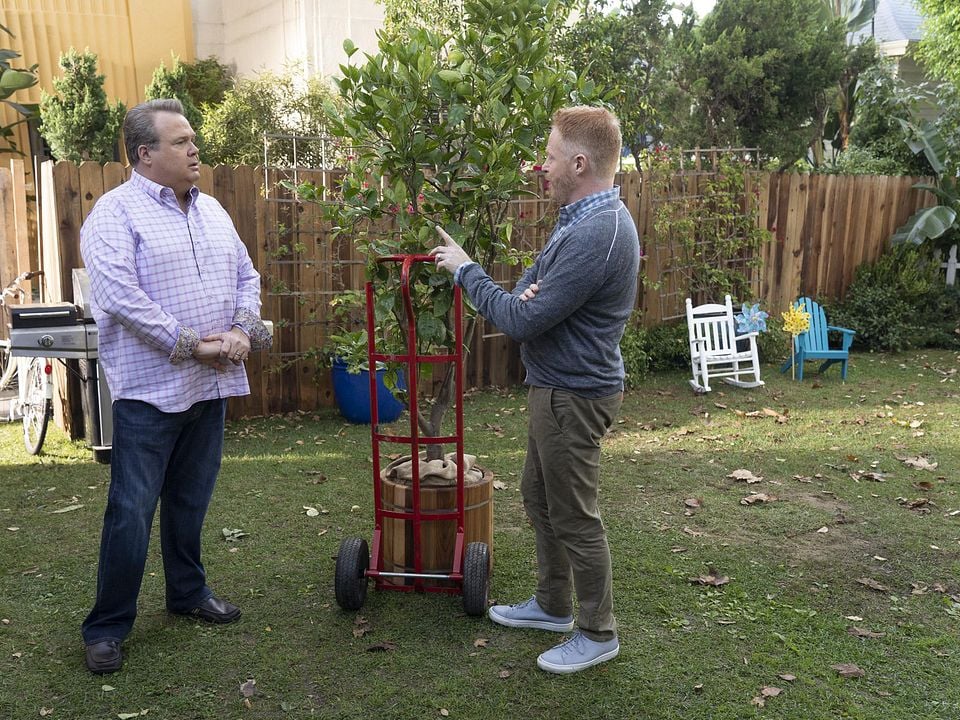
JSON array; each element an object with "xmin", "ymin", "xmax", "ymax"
[{"xmin": 433, "ymin": 107, "xmax": 640, "ymax": 673}]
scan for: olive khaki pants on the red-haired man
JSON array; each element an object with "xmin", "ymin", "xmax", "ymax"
[{"xmin": 520, "ymin": 387, "xmax": 623, "ymax": 641}]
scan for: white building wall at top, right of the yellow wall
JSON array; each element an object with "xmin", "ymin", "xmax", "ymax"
[{"xmin": 191, "ymin": 0, "xmax": 383, "ymax": 75}]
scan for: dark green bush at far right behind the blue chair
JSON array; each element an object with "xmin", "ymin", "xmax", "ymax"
[{"xmin": 829, "ymin": 244, "xmax": 960, "ymax": 352}]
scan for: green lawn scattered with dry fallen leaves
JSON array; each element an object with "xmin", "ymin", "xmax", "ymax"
[{"xmin": 0, "ymin": 352, "xmax": 960, "ymax": 720}]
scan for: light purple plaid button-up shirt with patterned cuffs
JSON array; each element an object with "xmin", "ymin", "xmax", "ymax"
[{"xmin": 80, "ymin": 171, "xmax": 260, "ymax": 412}]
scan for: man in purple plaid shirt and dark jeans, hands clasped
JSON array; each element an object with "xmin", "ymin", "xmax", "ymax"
[{"xmin": 80, "ymin": 100, "xmax": 271, "ymax": 674}]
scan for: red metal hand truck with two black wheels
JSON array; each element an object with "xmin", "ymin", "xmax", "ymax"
[{"xmin": 334, "ymin": 255, "xmax": 490, "ymax": 616}]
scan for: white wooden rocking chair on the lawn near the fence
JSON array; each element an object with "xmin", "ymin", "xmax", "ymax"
[{"xmin": 687, "ymin": 295, "xmax": 763, "ymax": 393}]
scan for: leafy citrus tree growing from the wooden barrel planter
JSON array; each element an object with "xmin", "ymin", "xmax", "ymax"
[{"xmin": 297, "ymin": 0, "xmax": 595, "ymax": 459}]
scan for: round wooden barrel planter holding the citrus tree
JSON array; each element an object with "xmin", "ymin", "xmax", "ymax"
[{"xmin": 380, "ymin": 458, "xmax": 493, "ymax": 587}]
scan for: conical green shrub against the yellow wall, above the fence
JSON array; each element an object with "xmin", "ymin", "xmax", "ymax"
[{"xmin": 40, "ymin": 48, "xmax": 126, "ymax": 163}]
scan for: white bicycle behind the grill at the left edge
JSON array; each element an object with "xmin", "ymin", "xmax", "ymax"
[{"xmin": 0, "ymin": 270, "xmax": 53, "ymax": 455}]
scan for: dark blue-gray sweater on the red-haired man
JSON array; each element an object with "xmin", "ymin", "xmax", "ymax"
[{"xmin": 459, "ymin": 195, "xmax": 640, "ymax": 398}]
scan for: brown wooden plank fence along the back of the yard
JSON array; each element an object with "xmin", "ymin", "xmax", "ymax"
[{"xmin": 20, "ymin": 162, "xmax": 933, "ymax": 430}]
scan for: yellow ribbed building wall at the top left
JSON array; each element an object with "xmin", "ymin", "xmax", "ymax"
[{"xmin": 0, "ymin": 0, "xmax": 195, "ymax": 155}]
